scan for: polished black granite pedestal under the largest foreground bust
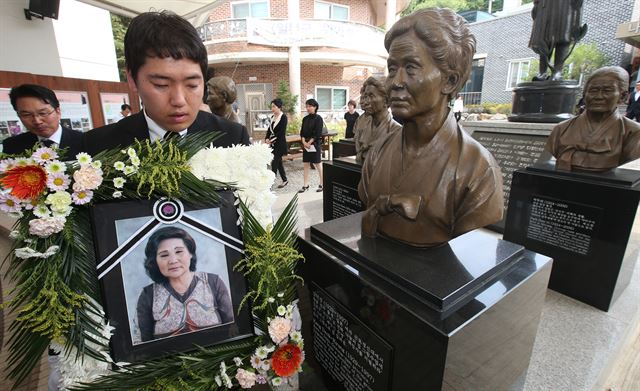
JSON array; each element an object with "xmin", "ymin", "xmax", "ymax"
[{"xmin": 300, "ymin": 213, "xmax": 551, "ymax": 391}]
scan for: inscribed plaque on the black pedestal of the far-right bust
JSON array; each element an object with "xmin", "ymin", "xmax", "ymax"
[{"xmin": 527, "ymin": 195, "xmax": 601, "ymax": 255}]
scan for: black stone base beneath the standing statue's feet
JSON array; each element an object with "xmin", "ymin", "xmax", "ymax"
[{"xmin": 508, "ymin": 80, "xmax": 580, "ymax": 122}]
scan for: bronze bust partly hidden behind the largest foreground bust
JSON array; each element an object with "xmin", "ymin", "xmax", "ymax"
[{"xmin": 353, "ymin": 77, "xmax": 402, "ymax": 163}]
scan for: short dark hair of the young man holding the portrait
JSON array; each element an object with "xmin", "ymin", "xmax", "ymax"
[{"xmin": 124, "ymin": 11, "xmax": 207, "ymax": 81}]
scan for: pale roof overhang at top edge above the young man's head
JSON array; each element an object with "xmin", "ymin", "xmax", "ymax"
[{"xmin": 78, "ymin": 0, "xmax": 221, "ymax": 19}]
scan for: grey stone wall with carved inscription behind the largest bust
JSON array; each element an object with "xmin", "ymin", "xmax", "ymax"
[{"xmin": 472, "ymin": 131, "xmax": 547, "ymax": 212}]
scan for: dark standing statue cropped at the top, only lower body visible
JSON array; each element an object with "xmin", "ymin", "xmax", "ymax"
[{"xmin": 529, "ymin": 0, "xmax": 587, "ymax": 81}]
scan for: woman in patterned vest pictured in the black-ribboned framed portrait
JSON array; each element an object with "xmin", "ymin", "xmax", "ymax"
[{"xmin": 137, "ymin": 227, "xmax": 233, "ymax": 342}]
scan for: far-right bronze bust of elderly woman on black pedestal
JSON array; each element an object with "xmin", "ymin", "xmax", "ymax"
[{"xmin": 547, "ymin": 66, "xmax": 640, "ymax": 171}]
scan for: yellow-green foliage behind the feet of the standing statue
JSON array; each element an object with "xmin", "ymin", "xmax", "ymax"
[{"xmin": 527, "ymin": 42, "xmax": 609, "ymax": 81}]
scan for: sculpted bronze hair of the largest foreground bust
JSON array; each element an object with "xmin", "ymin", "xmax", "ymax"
[{"xmin": 384, "ymin": 8, "xmax": 476, "ymax": 99}]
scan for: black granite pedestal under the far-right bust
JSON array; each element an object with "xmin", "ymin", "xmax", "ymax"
[{"xmin": 504, "ymin": 164, "xmax": 640, "ymax": 311}]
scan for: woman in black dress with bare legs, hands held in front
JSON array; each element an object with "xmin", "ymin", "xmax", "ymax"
[{"xmin": 298, "ymin": 99, "xmax": 324, "ymax": 193}]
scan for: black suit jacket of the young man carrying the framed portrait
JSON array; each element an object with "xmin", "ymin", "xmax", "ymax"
[{"xmin": 84, "ymin": 111, "xmax": 249, "ymax": 156}]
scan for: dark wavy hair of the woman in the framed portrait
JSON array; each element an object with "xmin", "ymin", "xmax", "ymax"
[{"xmin": 144, "ymin": 227, "xmax": 198, "ymax": 284}]
